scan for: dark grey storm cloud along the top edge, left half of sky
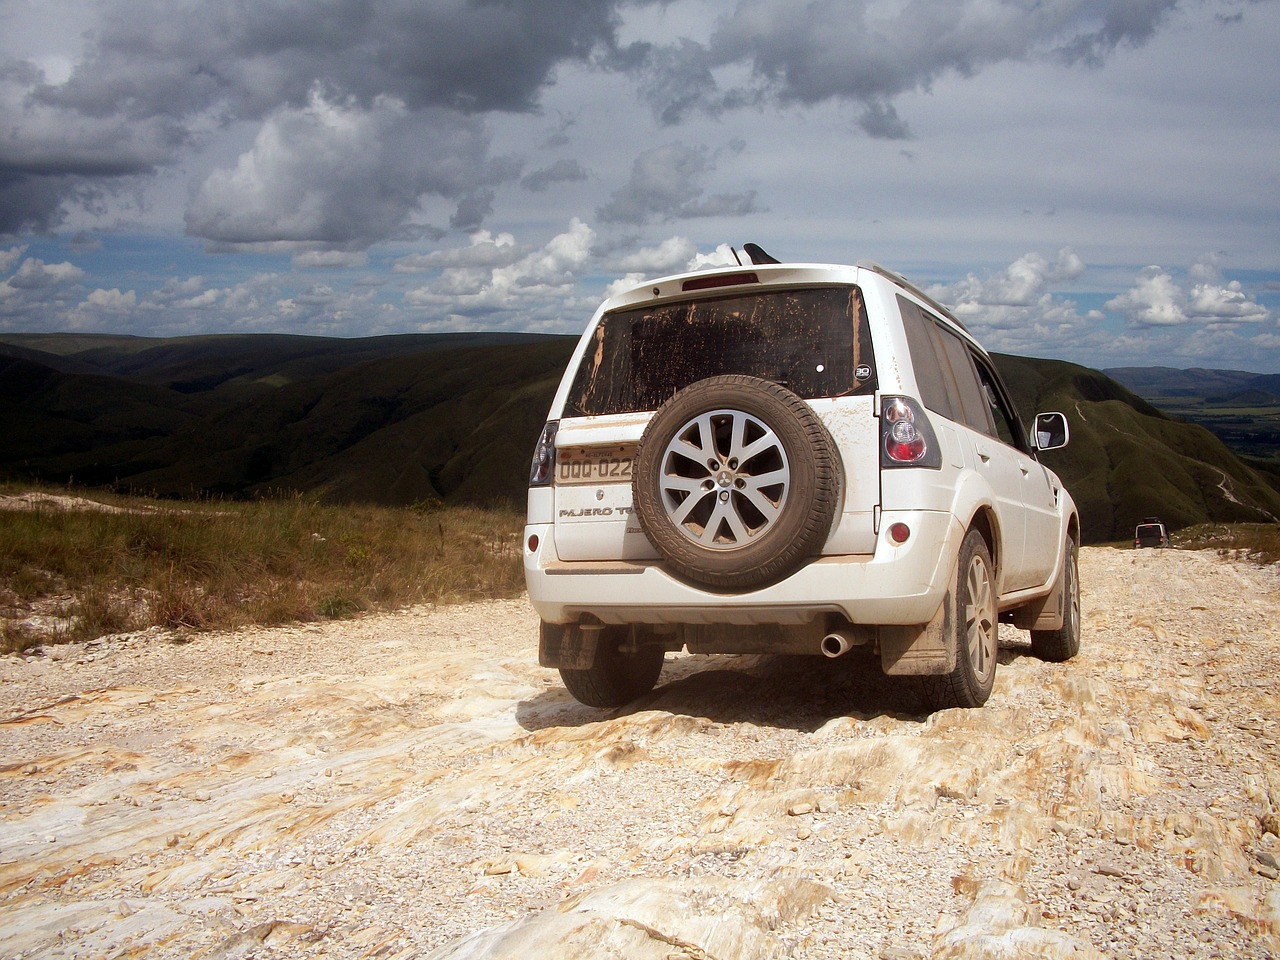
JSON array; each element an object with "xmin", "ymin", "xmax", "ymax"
[{"xmin": 37, "ymin": 0, "xmax": 616, "ymax": 118}]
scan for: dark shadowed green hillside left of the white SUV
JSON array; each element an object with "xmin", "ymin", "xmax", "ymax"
[{"xmin": 0, "ymin": 334, "xmax": 573, "ymax": 504}]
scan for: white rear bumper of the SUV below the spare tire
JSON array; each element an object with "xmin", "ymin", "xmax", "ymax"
[{"xmin": 525, "ymin": 511, "xmax": 964, "ymax": 625}]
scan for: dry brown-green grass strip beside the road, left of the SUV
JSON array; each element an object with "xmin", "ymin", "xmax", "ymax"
[{"xmin": 0, "ymin": 488, "xmax": 524, "ymax": 652}]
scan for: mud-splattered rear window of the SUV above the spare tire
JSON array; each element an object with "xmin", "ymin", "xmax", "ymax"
[{"xmin": 564, "ymin": 285, "xmax": 877, "ymax": 416}]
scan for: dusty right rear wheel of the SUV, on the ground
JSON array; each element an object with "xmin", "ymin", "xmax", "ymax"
[{"xmin": 924, "ymin": 530, "xmax": 1000, "ymax": 710}]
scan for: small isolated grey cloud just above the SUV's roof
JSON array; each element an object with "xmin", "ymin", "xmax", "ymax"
[{"xmin": 595, "ymin": 143, "xmax": 755, "ymax": 225}]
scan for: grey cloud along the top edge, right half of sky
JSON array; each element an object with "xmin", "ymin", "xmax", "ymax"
[{"xmin": 643, "ymin": 0, "xmax": 1179, "ymax": 138}]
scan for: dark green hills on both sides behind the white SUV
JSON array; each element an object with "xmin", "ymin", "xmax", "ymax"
[{"xmin": 0, "ymin": 334, "xmax": 1280, "ymax": 543}]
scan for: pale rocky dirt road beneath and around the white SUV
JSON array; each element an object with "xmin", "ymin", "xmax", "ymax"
[{"xmin": 0, "ymin": 548, "xmax": 1280, "ymax": 960}]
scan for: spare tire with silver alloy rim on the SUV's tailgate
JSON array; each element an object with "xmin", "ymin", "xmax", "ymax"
[{"xmin": 631, "ymin": 375, "xmax": 837, "ymax": 590}]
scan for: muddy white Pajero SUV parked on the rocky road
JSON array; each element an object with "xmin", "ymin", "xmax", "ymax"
[{"xmin": 525, "ymin": 252, "xmax": 1080, "ymax": 708}]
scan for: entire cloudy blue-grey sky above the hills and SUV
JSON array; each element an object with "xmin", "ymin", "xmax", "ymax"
[{"xmin": 0, "ymin": 0, "xmax": 1280, "ymax": 372}]
